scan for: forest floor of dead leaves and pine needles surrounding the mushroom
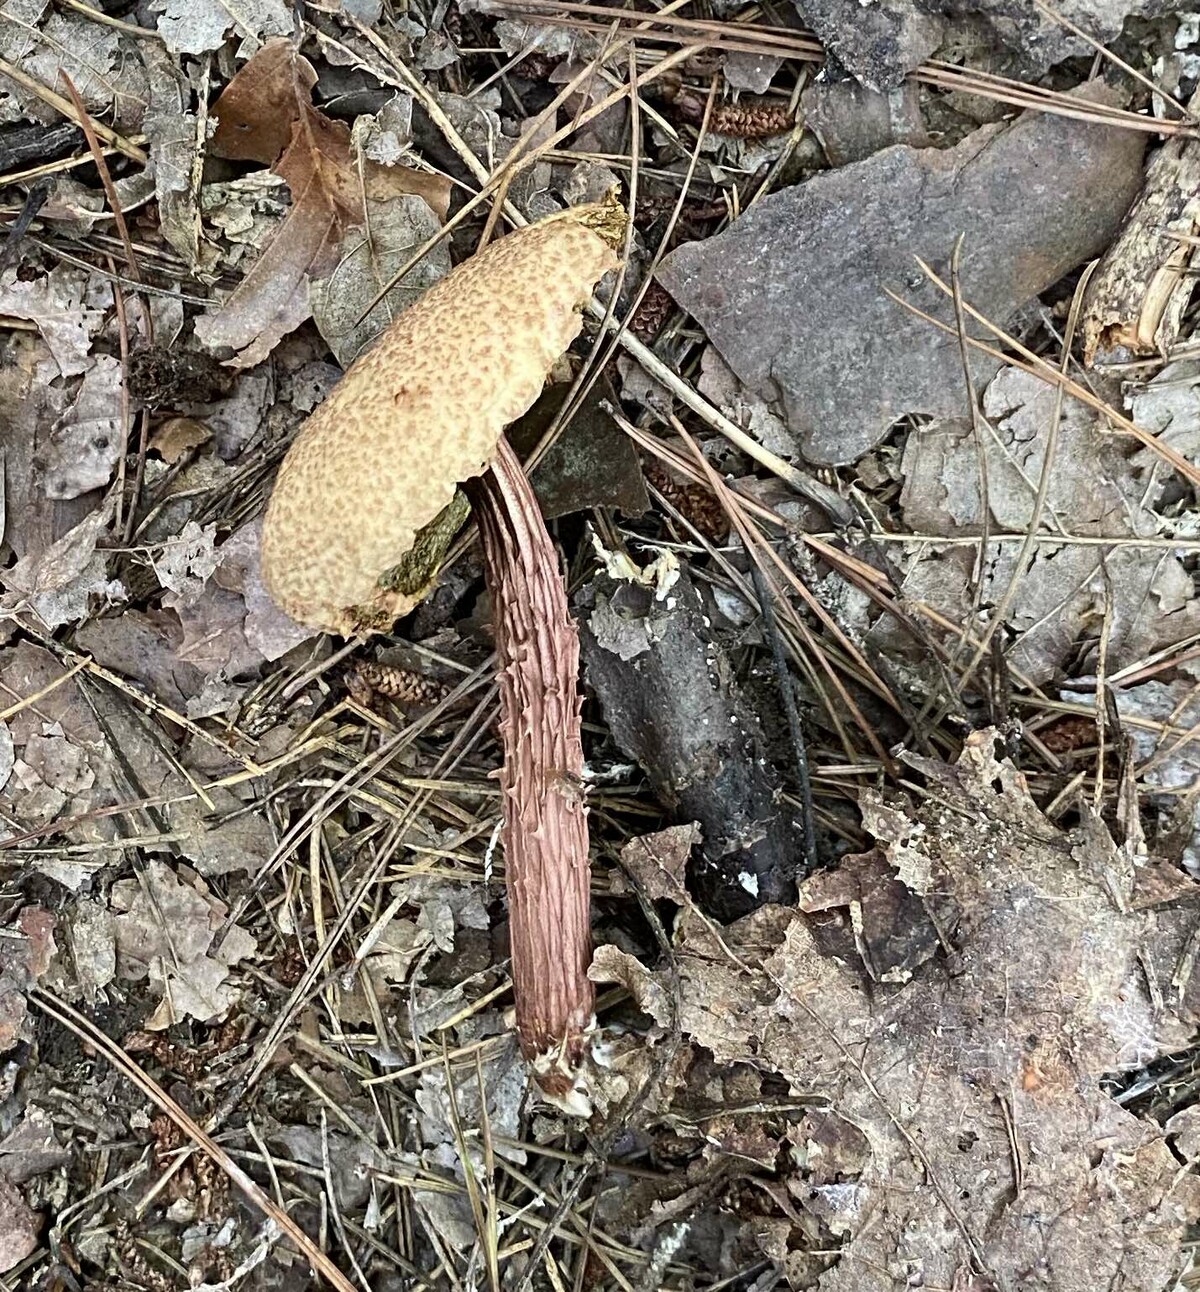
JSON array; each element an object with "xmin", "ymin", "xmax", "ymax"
[{"xmin": 9, "ymin": 0, "xmax": 1200, "ymax": 1292}]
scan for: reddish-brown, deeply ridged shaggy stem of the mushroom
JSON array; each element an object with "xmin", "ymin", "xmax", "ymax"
[{"xmin": 468, "ymin": 437, "xmax": 595, "ymax": 1096}]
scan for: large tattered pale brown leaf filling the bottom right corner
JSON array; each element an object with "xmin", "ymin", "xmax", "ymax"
[{"xmin": 598, "ymin": 731, "xmax": 1200, "ymax": 1292}]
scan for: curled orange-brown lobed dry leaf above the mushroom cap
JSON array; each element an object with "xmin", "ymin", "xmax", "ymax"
[{"xmin": 196, "ymin": 40, "xmax": 450, "ymax": 368}]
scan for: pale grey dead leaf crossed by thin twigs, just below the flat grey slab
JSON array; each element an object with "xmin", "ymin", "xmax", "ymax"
[{"xmin": 872, "ymin": 368, "xmax": 1200, "ymax": 683}]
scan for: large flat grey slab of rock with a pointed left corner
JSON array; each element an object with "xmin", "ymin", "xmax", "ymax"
[{"xmin": 657, "ymin": 87, "xmax": 1144, "ymax": 464}]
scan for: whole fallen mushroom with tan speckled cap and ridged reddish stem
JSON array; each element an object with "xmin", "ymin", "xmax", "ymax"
[{"xmin": 262, "ymin": 200, "xmax": 625, "ymax": 1097}]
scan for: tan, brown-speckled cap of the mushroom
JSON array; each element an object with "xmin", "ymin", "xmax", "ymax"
[{"xmin": 262, "ymin": 204, "xmax": 619, "ymax": 636}]
